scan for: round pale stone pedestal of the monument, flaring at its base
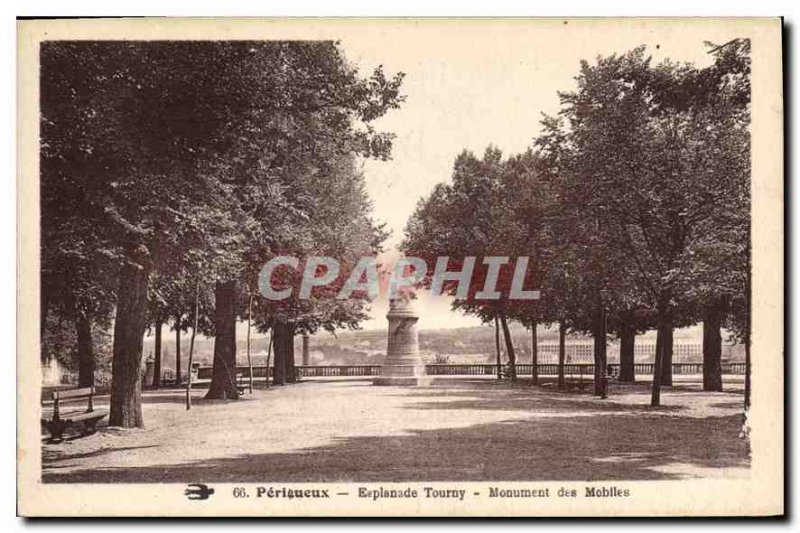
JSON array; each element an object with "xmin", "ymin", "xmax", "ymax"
[{"xmin": 372, "ymin": 298, "xmax": 430, "ymax": 385}]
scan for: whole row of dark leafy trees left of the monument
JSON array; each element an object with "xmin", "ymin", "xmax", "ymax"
[{"xmin": 41, "ymin": 41, "xmax": 403, "ymax": 427}]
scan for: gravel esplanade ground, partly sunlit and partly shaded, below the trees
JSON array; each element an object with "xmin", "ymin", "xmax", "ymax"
[{"xmin": 42, "ymin": 376, "xmax": 749, "ymax": 483}]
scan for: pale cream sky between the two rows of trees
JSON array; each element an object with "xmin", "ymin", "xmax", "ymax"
[{"xmin": 328, "ymin": 19, "xmax": 742, "ymax": 329}]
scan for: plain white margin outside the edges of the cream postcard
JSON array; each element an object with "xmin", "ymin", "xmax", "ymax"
[{"xmin": 0, "ymin": 0, "xmax": 800, "ymax": 530}]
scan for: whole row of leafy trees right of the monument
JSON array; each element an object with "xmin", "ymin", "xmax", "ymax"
[{"xmin": 402, "ymin": 39, "xmax": 750, "ymax": 405}]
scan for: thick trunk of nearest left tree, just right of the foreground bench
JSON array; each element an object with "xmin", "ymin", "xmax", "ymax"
[{"xmin": 108, "ymin": 254, "xmax": 151, "ymax": 428}]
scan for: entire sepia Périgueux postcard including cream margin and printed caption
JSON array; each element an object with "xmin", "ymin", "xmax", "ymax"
[{"xmin": 17, "ymin": 18, "xmax": 784, "ymax": 517}]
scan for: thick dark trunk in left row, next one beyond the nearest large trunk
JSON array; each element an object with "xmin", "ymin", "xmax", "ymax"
[{"xmin": 206, "ymin": 280, "xmax": 239, "ymax": 400}]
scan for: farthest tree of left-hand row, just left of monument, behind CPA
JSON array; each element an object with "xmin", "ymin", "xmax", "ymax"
[{"xmin": 247, "ymin": 150, "xmax": 386, "ymax": 383}]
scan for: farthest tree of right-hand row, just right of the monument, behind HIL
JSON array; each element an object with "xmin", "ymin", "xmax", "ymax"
[{"xmin": 401, "ymin": 146, "xmax": 532, "ymax": 381}]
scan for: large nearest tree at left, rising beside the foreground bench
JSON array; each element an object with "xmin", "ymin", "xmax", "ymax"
[{"xmin": 41, "ymin": 42, "xmax": 256, "ymax": 426}]
